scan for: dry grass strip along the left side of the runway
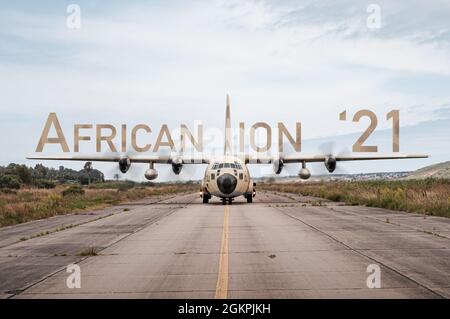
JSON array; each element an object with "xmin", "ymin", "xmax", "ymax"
[{"xmin": 0, "ymin": 184, "xmax": 199, "ymax": 227}]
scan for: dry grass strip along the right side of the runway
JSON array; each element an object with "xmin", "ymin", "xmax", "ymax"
[{"xmin": 259, "ymin": 179, "xmax": 450, "ymax": 217}]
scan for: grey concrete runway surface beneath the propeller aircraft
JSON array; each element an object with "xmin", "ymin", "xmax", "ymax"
[{"xmin": 0, "ymin": 192, "xmax": 450, "ymax": 298}]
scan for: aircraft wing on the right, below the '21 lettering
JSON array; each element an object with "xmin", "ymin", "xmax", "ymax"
[{"xmin": 244, "ymin": 153, "xmax": 428, "ymax": 164}]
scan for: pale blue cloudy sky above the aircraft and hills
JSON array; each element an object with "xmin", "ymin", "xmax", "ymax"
[{"xmin": 0, "ymin": 0, "xmax": 450, "ymax": 180}]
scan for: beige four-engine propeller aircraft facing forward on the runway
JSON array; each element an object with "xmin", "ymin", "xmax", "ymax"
[{"xmin": 27, "ymin": 96, "xmax": 428, "ymax": 204}]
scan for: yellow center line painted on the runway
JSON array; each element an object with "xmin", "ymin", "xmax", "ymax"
[{"xmin": 215, "ymin": 206, "xmax": 230, "ymax": 299}]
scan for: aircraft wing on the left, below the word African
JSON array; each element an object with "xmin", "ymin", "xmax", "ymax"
[{"xmin": 27, "ymin": 155, "xmax": 209, "ymax": 164}]
